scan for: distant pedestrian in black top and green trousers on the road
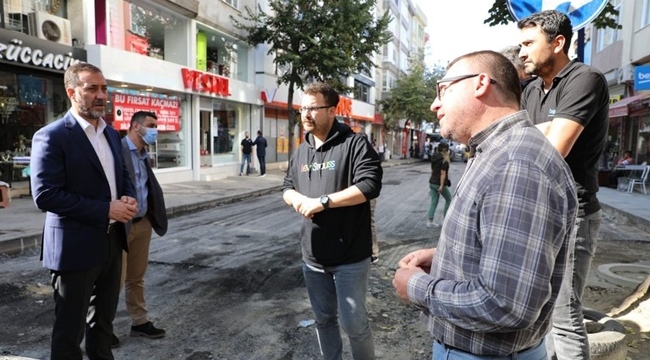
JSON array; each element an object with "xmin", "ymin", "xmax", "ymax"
[{"xmin": 427, "ymin": 142, "xmax": 451, "ymax": 227}]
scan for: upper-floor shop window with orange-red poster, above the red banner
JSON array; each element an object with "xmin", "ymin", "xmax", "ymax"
[{"xmin": 109, "ymin": 0, "xmax": 188, "ymax": 65}]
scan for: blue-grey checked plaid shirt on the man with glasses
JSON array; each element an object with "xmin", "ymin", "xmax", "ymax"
[{"xmin": 408, "ymin": 111, "xmax": 577, "ymax": 356}]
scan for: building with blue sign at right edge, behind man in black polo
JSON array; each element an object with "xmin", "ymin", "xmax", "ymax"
[{"xmin": 588, "ymin": 0, "xmax": 650, "ymax": 168}]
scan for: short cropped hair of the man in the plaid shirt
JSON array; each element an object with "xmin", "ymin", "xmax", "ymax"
[{"xmin": 447, "ymin": 50, "xmax": 521, "ymax": 104}]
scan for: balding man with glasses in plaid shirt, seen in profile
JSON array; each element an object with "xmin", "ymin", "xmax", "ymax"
[{"xmin": 393, "ymin": 51, "xmax": 578, "ymax": 360}]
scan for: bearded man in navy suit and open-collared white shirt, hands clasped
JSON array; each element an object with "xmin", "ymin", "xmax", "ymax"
[{"xmin": 31, "ymin": 63, "xmax": 138, "ymax": 360}]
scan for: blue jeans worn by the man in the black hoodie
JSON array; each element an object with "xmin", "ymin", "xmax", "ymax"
[{"xmin": 302, "ymin": 258, "xmax": 375, "ymax": 360}]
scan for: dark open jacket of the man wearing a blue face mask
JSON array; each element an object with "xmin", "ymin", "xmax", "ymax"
[{"xmin": 122, "ymin": 136, "xmax": 167, "ymax": 236}]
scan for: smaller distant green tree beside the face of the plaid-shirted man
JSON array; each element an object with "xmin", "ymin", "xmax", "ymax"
[{"xmin": 378, "ymin": 60, "xmax": 444, "ymax": 129}]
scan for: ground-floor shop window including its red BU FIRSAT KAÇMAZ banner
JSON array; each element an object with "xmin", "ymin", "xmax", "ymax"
[{"xmin": 106, "ymin": 87, "xmax": 190, "ymax": 169}]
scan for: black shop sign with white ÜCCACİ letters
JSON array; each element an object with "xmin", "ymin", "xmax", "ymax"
[{"xmin": 0, "ymin": 29, "xmax": 86, "ymax": 72}]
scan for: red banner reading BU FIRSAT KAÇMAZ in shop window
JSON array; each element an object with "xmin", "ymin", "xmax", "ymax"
[{"xmin": 113, "ymin": 93, "xmax": 181, "ymax": 131}]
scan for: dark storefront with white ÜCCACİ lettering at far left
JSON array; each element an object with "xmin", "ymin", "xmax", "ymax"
[{"xmin": 0, "ymin": 29, "xmax": 86, "ymax": 187}]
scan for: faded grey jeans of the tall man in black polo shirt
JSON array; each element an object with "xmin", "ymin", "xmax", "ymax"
[{"xmin": 546, "ymin": 210, "xmax": 602, "ymax": 360}]
